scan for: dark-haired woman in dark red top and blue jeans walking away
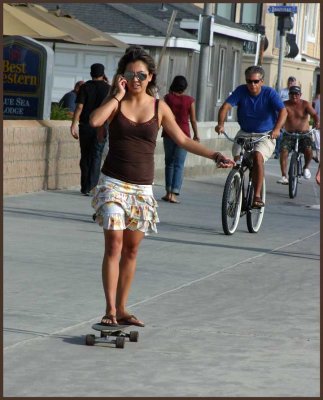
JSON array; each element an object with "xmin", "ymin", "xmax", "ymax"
[{"xmin": 162, "ymin": 75, "xmax": 200, "ymax": 203}]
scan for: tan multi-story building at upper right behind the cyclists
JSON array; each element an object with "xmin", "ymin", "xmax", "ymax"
[{"xmin": 199, "ymin": 2, "xmax": 321, "ymax": 104}]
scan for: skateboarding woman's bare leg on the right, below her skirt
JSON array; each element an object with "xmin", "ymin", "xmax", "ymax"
[{"xmin": 116, "ymin": 230, "xmax": 144, "ymax": 317}]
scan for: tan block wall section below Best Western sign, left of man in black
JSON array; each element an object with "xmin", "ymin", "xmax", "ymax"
[{"xmin": 3, "ymin": 121, "xmax": 80, "ymax": 195}]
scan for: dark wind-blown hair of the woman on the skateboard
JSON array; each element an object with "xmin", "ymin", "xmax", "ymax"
[{"xmin": 110, "ymin": 46, "xmax": 157, "ymax": 97}]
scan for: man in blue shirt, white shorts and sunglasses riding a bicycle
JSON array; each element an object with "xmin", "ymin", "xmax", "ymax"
[{"xmin": 215, "ymin": 66, "xmax": 287, "ymax": 208}]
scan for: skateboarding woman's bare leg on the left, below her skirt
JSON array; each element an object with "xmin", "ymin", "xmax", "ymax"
[{"xmin": 102, "ymin": 230, "xmax": 123, "ymax": 323}]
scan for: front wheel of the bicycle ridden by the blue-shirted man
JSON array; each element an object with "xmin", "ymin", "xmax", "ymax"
[{"xmin": 222, "ymin": 169, "xmax": 242, "ymax": 235}]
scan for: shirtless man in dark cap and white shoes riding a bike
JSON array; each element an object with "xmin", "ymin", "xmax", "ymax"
[{"xmin": 277, "ymin": 86, "xmax": 320, "ymax": 185}]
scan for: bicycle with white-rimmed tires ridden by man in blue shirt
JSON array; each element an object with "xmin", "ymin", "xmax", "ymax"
[{"xmin": 222, "ymin": 132, "xmax": 270, "ymax": 235}]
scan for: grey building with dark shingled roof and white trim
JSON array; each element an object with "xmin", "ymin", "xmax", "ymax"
[{"xmin": 44, "ymin": 3, "xmax": 260, "ymax": 121}]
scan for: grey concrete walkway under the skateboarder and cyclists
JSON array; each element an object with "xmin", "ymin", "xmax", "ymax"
[{"xmin": 4, "ymin": 159, "xmax": 320, "ymax": 397}]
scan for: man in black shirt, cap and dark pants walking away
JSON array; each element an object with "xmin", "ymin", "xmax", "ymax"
[{"xmin": 70, "ymin": 64, "xmax": 110, "ymax": 196}]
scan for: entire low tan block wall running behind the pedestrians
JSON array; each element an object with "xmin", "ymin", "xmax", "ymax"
[{"xmin": 3, "ymin": 120, "xmax": 237, "ymax": 195}]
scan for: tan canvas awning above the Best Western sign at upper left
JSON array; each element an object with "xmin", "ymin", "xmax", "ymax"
[{"xmin": 3, "ymin": 3, "xmax": 128, "ymax": 49}]
